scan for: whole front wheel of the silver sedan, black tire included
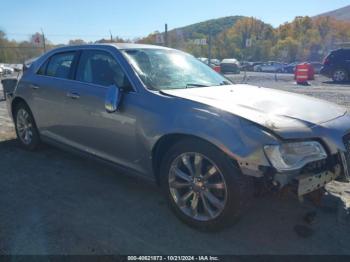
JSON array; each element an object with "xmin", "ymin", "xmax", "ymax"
[{"xmin": 161, "ymin": 139, "xmax": 253, "ymax": 231}]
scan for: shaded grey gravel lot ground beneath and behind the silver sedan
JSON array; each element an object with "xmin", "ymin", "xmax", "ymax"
[{"xmin": 0, "ymin": 73, "xmax": 350, "ymax": 254}]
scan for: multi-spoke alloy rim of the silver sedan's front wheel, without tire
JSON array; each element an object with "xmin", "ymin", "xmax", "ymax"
[{"xmin": 168, "ymin": 152, "xmax": 227, "ymax": 221}]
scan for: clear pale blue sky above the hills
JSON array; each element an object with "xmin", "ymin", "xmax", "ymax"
[{"xmin": 0, "ymin": 0, "xmax": 350, "ymax": 44}]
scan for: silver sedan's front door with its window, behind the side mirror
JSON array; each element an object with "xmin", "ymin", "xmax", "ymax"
[{"xmin": 64, "ymin": 50, "xmax": 139, "ymax": 169}]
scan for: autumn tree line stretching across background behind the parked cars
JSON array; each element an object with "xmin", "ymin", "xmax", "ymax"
[{"xmin": 0, "ymin": 16, "xmax": 350, "ymax": 63}]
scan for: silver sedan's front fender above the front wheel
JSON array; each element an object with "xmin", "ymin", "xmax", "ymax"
[{"xmin": 143, "ymin": 93, "xmax": 278, "ymax": 177}]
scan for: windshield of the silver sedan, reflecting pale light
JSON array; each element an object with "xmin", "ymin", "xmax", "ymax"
[{"xmin": 124, "ymin": 49, "xmax": 232, "ymax": 90}]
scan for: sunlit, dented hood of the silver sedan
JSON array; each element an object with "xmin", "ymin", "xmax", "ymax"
[{"xmin": 162, "ymin": 85, "xmax": 346, "ymax": 131}]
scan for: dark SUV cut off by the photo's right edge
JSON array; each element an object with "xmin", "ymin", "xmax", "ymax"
[{"xmin": 320, "ymin": 48, "xmax": 350, "ymax": 82}]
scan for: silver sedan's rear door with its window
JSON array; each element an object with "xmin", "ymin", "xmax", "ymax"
[{"xmin": 30, "ymin": 51, "xmax": 77, "ymax": 137}]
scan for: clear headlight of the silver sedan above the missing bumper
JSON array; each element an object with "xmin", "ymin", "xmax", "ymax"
[{"xmin": 264, "ymin": 141, "xmax": 327, "ymax": 171}]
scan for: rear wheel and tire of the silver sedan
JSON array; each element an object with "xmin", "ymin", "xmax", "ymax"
[{"xmin": 14, "ymin": 102, "xmax": 40, "ymax": 151}]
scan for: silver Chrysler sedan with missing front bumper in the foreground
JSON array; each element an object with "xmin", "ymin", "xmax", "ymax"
[{"xmin": 7, "ymin": 44, "xmax": 350, "ymax": 229}]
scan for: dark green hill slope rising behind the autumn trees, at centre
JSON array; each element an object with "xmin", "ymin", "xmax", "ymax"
[{"xmin": 169, "ymin": 16, "xmax": 243, "ymax": 39}]
